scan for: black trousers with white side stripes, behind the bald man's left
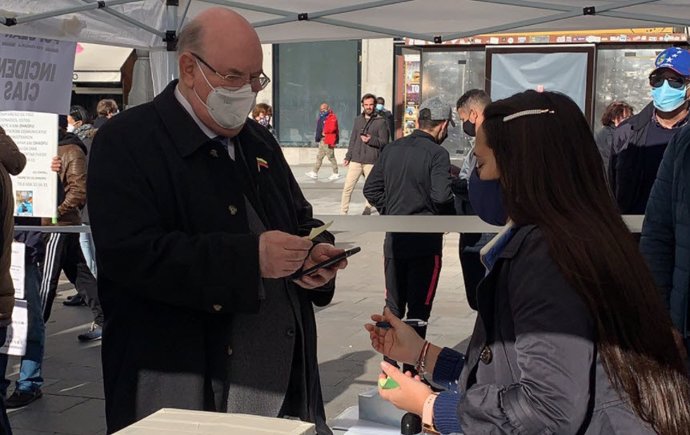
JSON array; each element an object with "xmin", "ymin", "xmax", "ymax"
[{"xmin": 39, "ymin": 233, "xmax": 103, "ymax": 326}]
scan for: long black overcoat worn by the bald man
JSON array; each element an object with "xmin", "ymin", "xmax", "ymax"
[{"xmin": 88, "ymin": 81, "xmax": 334, "ymax": 432}]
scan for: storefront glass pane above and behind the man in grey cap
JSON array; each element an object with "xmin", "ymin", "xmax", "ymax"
[{"xmin": 422, "ymin": 49, "xmax": 486, "ymax": 158}]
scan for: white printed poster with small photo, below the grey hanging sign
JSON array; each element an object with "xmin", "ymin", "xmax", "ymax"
[{"xmin": 0, "ymin": 112, "xmax": 58, "ymax": 218}]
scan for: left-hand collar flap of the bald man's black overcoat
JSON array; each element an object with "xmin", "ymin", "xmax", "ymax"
[{"xmin": 153, "ymin": 80, "xmax": 222, "ymax": 157}]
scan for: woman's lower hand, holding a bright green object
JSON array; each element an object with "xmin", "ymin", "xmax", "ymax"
[{"xmin": 379, "ymin": 362, "xmax": 433, "ymax": 417}]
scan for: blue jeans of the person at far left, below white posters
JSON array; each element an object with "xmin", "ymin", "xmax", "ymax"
[{"xmin": 0, "ymin": 263, "xmax": 45, "ymax": 396}]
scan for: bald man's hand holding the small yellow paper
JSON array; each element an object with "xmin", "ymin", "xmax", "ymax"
[{"xmin": 259, "ymin": 231, "xmax": 312, "ymax": 278}]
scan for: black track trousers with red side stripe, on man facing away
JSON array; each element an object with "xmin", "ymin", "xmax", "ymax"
[{"xmin": 383, "ymin": 254, "xmax": 441, "ymax": 374}]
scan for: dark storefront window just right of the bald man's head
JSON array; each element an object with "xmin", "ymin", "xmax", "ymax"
[{"xmin": 274, "ymin": 41, "xmax": 360, "ymax": 147}]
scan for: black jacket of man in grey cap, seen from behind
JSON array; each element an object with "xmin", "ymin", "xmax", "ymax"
[{"xmin": 363, "ymin": 130, "xmax": 455, "ymax": 258}]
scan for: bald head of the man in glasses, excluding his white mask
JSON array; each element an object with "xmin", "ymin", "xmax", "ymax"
[{"xmin": 177, "ymin": 7, "xmax": 263, "ymax": 137}]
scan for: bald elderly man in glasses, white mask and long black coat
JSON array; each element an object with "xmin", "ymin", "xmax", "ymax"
[{"xmin": 89, "ymin": 8, "xmax": 345, "ymax": 434}]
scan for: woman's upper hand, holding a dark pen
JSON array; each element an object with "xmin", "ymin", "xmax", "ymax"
[{"xmin": 364, "ymin": 307, "xmax": 424, "ymax": 364}]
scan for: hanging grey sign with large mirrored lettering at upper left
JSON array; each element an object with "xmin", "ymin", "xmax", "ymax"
[{"xmin": 0, "ymin": 35, "xmax": 77, "ymax": 115}]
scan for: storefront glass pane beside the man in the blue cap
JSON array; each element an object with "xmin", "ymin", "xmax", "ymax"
[{"xmin": 593, "ymin": 47, "xmax": 666, "ymax": 131}]
